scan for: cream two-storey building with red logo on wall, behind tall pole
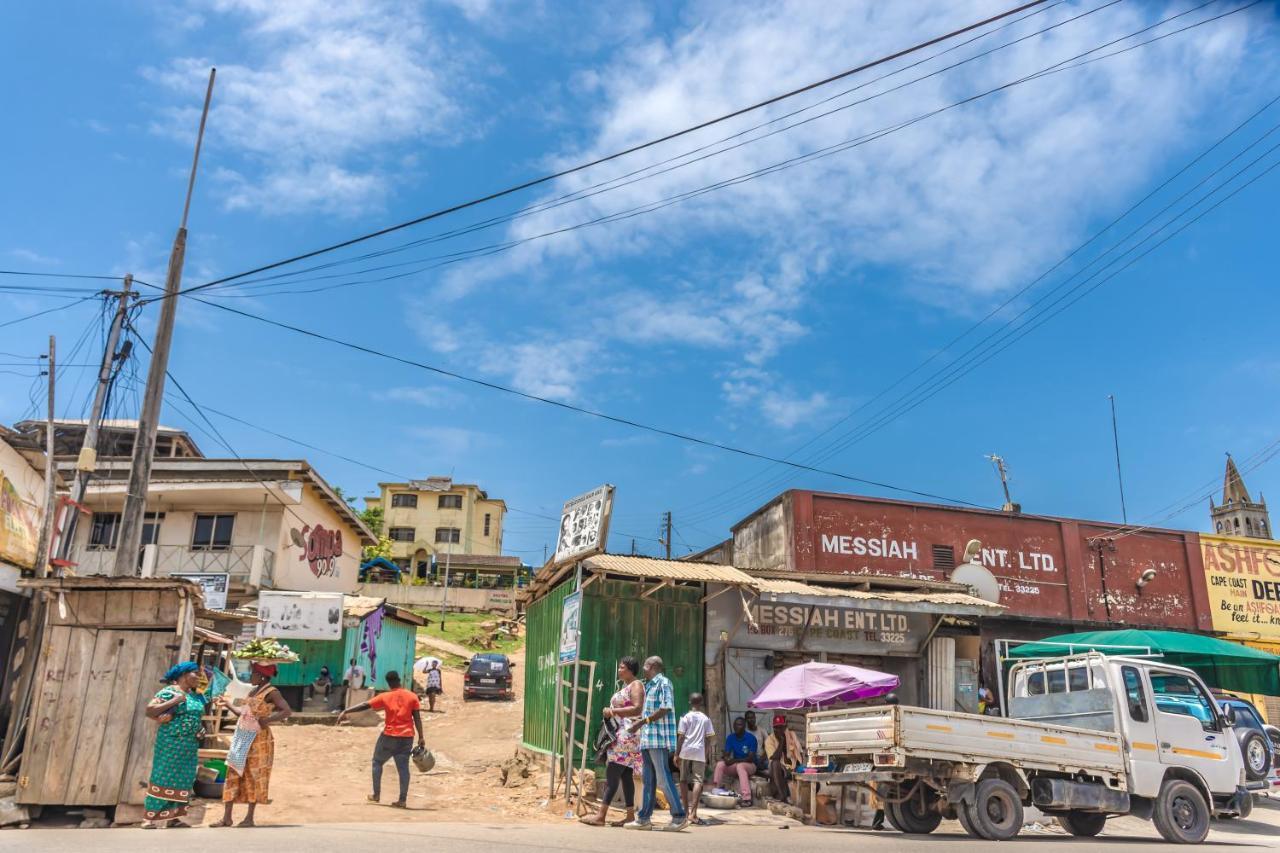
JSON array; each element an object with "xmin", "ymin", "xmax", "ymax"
[{"xmin": 17, "ymin": 421, "xmax": 375, "ymax": 596}]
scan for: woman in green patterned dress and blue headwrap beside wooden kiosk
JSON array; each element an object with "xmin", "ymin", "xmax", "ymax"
[{"xmin": 143, "ymin": 662, "xmax": 205, "ymax": 829}]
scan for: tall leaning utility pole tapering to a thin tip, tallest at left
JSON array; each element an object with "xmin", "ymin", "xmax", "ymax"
[{"xmin": 111, "ymin": 68, "xmax": 218, "ymax": 578}]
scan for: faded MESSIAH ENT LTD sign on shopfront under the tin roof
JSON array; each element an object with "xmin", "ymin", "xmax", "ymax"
[{"xmin": 750, "ymin": 602, "xmax": 933, "ymax": 653}]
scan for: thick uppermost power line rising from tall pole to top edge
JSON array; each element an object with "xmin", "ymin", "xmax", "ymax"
[{"xmin": 152, "ymin": 0, "xmax": 1046, "ymax": 298}]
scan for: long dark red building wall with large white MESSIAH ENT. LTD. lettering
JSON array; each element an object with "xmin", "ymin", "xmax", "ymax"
[{"xmin": 732, "ymin": 491, "xmax": 1212, "ymax": 637}]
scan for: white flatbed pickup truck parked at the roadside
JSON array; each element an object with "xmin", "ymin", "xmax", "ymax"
[{"xmin": 806, "ymin": 652, "xmax": 1267, "ymax": 844}]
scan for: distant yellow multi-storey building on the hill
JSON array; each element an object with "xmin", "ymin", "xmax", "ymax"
[{"xmin": 365, "ymin": 476, "xmax": 504, "ymax": 575}]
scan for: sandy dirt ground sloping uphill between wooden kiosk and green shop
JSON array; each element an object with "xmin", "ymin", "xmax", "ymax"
[{"xmin": 194, "ymin": 651, "xmax": 557, "ymax": 825}]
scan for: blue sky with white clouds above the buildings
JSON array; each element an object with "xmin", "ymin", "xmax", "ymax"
[{"xmin": 0, "ymin": 0, "xmax": 1280, "ymax": 562}]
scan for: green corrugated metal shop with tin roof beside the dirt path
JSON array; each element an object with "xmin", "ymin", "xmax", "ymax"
[{"xmin": 522, "ymin": 555, "xmax": 722, "ymax": 753}]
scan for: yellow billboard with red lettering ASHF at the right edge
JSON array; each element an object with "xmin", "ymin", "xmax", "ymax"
[{"xmin": 1201, "ymin": 533, "xmax": 1280, "ymax": 642}]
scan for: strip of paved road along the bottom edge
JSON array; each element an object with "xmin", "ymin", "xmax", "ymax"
[{"xmin": 0, "ymin": 821, "xmax": 1280, "ymax": 853}]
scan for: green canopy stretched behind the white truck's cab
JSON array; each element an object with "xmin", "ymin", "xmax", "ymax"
[{"xmin": 1009, "ymin": 630, "xmax": 1280, "ymax": 695}]
